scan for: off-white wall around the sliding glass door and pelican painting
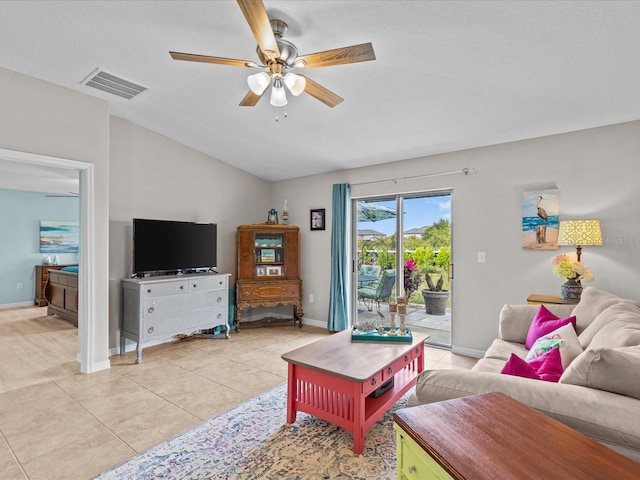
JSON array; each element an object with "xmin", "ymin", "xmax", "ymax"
[{"xmin": 272, "ymin": 122, "xmax": 640, "ymax": 352}]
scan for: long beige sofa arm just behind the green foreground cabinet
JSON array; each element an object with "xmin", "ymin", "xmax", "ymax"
[{"xmin": 408, "ymin": 370, "xmax": 640, "ymax": 449}]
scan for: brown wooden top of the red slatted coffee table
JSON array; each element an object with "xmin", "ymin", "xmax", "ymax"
[{"xmin": 282, "ymin": 330, "xmax": 429, "ymax": 382}]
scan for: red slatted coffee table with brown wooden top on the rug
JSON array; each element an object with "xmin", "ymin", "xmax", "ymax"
[{"xmin": 282, "ymin": 330, "xmax": 429, "ymax": 454}]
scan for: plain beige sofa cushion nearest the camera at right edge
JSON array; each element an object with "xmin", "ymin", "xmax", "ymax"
[{"xmin": 560, "ymin": 346, "xmax": 640, "ymax": 399}]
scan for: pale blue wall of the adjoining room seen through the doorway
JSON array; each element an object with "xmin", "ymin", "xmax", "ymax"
[{"xmin": 0, "ymin": 188, "xmax": 80, "ymax": 307}]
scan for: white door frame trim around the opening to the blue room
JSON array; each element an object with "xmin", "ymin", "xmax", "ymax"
[{"xmin": 0, "ymin": 149, "xmax": 95, "ymax": 373}]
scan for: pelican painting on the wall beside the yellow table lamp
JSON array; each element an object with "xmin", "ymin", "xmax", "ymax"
[{"xmin": 522, "ymin": 189, "xmax": 558, "ymax": 250}]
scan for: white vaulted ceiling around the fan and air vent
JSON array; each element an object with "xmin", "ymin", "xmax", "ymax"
[{"xmin": 0, "ymin": 0, "xmax": 640, "ymax": 191}]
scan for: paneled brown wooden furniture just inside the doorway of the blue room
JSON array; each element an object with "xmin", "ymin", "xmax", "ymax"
[{"xmin": 45, "ymin": 267, "xmax": 78, "ymax": 327}]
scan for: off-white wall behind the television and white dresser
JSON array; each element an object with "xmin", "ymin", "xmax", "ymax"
[{"xmin": 109, "ymin": 117, "xmax": 270, "ymax": 351}]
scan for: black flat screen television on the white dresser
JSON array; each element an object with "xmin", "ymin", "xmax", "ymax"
[{"xmin": 132, "ymin": 218, "xmax": 218, "ymax": 276}]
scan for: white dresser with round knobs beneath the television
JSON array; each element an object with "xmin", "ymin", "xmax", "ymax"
[{"xmin": 120, "ymin": 274, "xmax": 229, "ymax": 363}]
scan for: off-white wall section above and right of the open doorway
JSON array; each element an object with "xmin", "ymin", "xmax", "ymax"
[{"xmin": 0, "ymin": 68, "xmax": 109, "ymax": 366}]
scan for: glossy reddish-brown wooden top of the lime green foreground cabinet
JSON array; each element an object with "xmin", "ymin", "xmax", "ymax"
[{"xmin": 394, "ymin": 393, "xmax": 640, "ymax": 480}]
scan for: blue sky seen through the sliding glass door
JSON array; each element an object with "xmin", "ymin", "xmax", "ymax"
[{"xmin": 358, "ymin": 195, "xmax": 451, "ymax": 235}]
